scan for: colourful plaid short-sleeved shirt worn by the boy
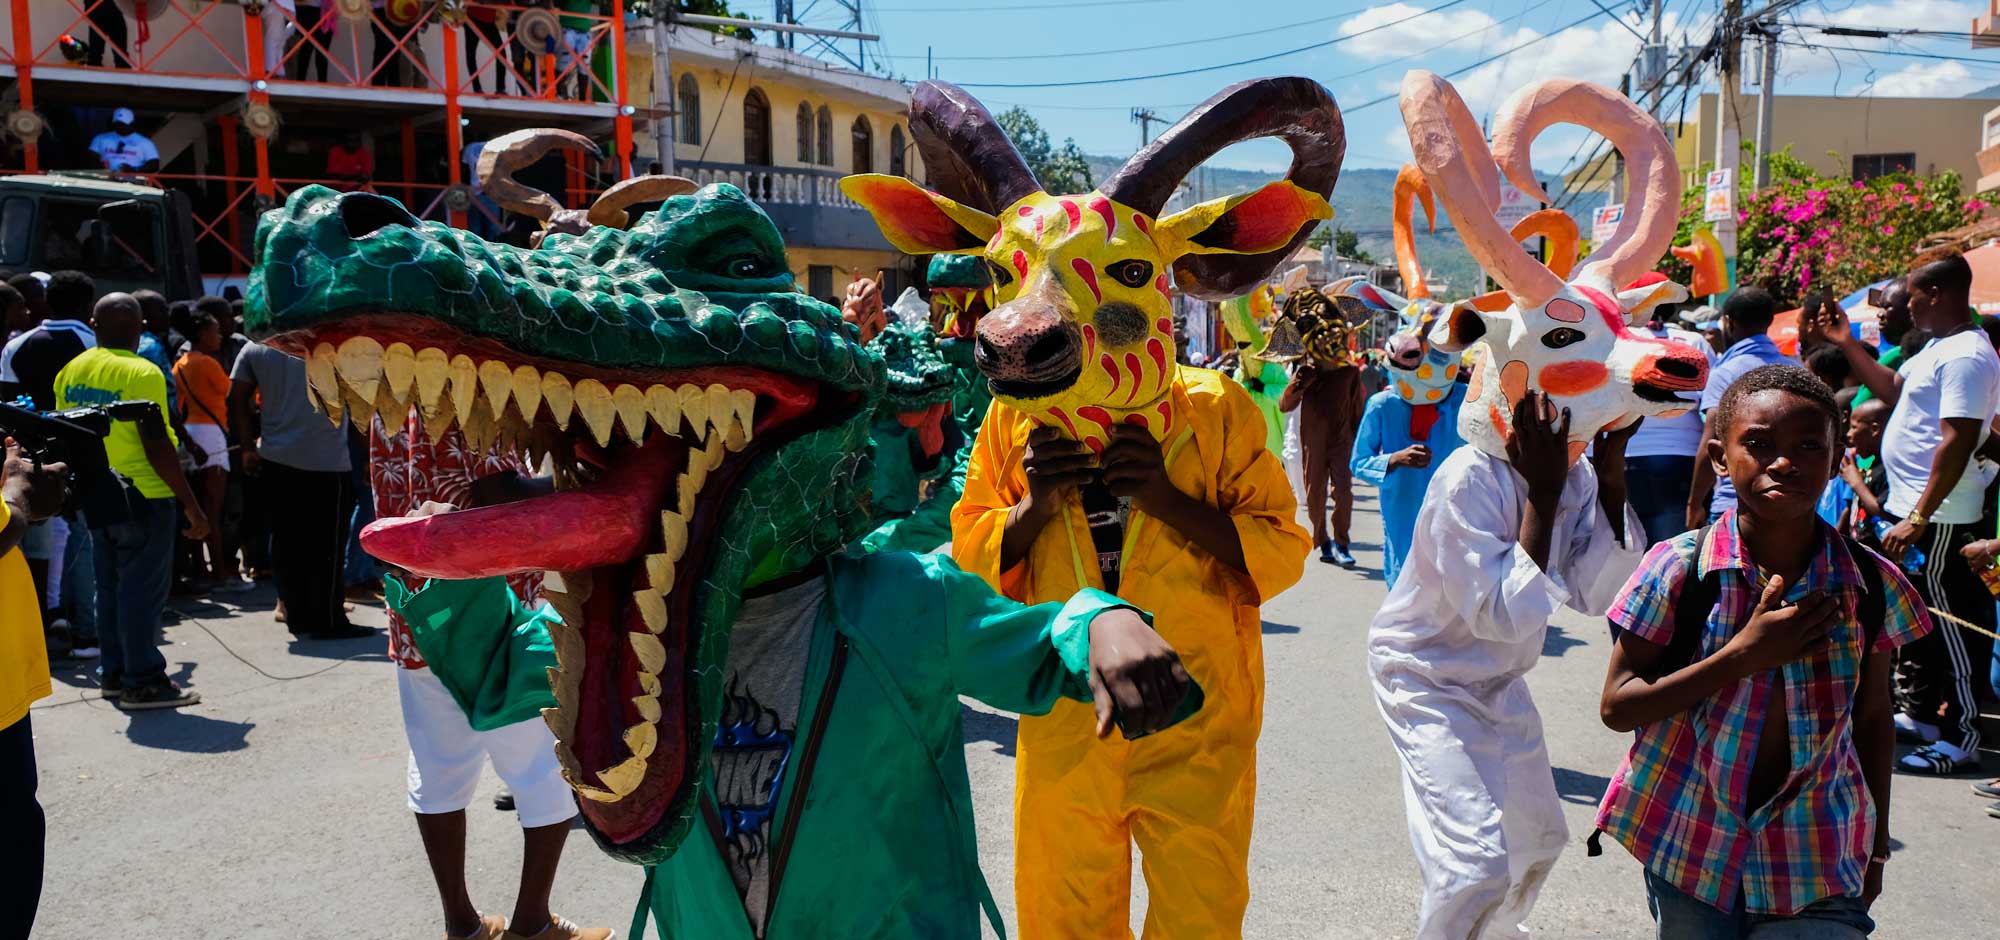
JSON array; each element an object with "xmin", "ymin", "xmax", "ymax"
[{"xmin": 1598, "ymin": 510, "xmax": 1930, "ymax": 914}]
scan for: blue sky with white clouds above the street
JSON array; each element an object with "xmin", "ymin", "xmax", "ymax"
[{"xmin": 788, "ymin": 0, "xmax": 2000, "ymax": 172}]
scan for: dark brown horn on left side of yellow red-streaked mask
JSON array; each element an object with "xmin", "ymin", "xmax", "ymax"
[{"xmin": 910, "ymin": 82, "xmax": 1042, "ymax": 214}]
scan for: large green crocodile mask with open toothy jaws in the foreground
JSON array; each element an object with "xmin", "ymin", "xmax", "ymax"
[{"xmin": 246, "ymin": 174, "xmax": 884, "ymax": 864}]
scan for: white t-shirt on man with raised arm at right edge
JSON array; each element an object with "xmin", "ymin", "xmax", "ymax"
[{"xmin": 1882, "ymin": 330, "xmax": 2000, "ymax": 524}]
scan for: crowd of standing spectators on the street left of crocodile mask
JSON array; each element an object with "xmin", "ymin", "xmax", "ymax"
[{"xmin": 0, "ymin": 270, "xmax": 374, "ymax": 710}]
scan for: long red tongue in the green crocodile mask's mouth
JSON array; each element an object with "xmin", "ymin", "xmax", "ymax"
[{"xmin": 362, "ymin": 434, "xmax": 688, "ymax": 580}]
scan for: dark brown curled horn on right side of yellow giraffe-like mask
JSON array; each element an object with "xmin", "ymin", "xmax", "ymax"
[{"xmin": 1098, "ymin": 78, "xmax": 1348, "ymax": 296}]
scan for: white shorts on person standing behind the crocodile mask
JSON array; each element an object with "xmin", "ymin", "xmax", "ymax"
[{"xmin": 396, "ymin": 668, "xmax": 576, "ymax": 828}]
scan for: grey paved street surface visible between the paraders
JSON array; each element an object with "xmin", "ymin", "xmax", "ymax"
[{"xmin": 34, "ymin": 488, "xmax": 2000, "ymax": 940}]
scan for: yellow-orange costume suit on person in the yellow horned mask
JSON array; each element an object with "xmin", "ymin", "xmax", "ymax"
[{"xmin": 952, "ymin": 368, "xmax": 1308, "ymax": 940}]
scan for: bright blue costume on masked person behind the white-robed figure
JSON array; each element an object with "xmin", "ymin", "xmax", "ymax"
[{"xmin": 1348, "ymin": 382, "xmax": 1466, "ymax": 586}]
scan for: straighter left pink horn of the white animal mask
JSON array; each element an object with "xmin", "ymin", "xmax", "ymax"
[{"xmin": 1400, "ymin": 70, "xmax": 1562, "ymax": 308}]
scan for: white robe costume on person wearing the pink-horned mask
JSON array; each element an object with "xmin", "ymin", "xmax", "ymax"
[{"xmin": 1368, "ymin": 446, "xmax": 1646, "ymax": 940}]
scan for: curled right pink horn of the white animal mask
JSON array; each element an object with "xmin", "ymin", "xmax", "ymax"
[{"xmin": 1496, "ymin": 78, "xmax": 1680, "ymax": 286}]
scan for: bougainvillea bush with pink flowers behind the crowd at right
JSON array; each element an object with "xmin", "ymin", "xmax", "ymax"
[{"xmin": 1662, "ymin": 150, "xmax": 1986, "ymax": 304}]
